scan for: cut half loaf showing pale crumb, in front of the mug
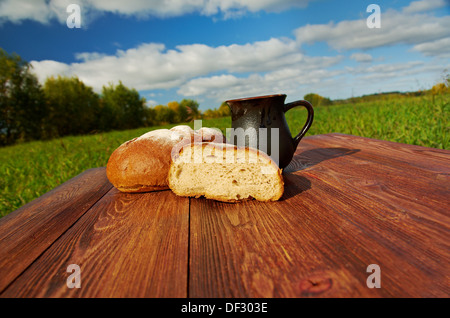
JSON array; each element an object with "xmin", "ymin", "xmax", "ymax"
[{"xmin": 169, "ymin": 143, "xmax": 284, "ymax": 202}]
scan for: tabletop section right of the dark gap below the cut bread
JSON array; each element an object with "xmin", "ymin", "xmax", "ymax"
[{"xmin": 189, "ymin": 134, "xmax": 450, "ymax": 297}]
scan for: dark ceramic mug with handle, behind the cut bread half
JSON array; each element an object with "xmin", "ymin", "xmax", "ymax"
[{"xmin": 226, "ymin": 94, "xmax": 314, "ymax": 168}]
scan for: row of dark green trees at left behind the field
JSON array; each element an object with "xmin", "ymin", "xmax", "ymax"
[{"xmin": 0, "ymin": 48, "xmax": 229, "ymax": 146}]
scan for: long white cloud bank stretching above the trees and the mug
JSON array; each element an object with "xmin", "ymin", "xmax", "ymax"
[{"xmin": 31, "ymin": 35, "xmax": 344, "ymax": 100}]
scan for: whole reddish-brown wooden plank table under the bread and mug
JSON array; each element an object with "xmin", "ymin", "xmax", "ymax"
[{"xmin": 0, "ymin": 134, "xmax": 450, "ymax": 298}]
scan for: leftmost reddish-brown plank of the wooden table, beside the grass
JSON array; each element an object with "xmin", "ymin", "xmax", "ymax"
[{"xmin": 0, "ymin": 168, "xmax": 112, "ymax": 292}]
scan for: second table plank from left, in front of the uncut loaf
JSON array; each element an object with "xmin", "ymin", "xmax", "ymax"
[{"xmin": 1, "ymin": 188, "xmax": 189, "ymax": 298}]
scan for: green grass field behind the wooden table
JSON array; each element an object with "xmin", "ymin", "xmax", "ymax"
[{"xmin": 0, "ymin": 94, "xmax": 450, "ymax": 216}]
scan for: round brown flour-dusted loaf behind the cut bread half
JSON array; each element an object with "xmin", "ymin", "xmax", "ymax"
[{"xmin": 106, "ymin": 125, "xmax": 226, "ymax": 192}]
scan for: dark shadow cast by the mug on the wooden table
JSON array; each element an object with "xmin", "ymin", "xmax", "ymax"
[{"xmin": 284, "ymin": 147, "xmax": 361, "ymax": 173}]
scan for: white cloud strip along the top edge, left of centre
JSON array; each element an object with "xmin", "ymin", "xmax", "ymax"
[{"xmin": 0, "ymin": 0, "xmax": 313, "ymax": 24}]
